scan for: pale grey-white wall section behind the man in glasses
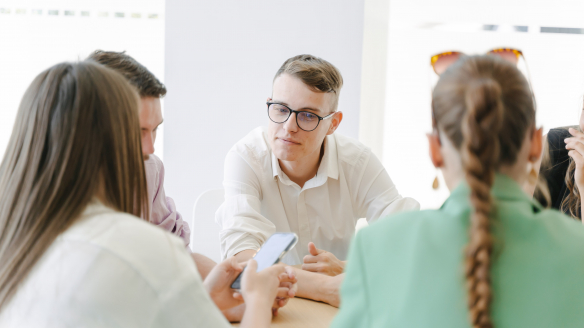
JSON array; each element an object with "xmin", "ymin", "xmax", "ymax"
[{"xmin": 164, "ymin": 0, "xmax": 363, "ymax": 220}]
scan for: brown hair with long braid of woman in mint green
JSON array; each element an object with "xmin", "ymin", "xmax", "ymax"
[{"xmin": 432, "ymin": 55, "xmax": 535, "ymax": 328}]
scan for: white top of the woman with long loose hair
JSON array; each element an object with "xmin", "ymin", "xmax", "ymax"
[{"xmin": 0, "ymin": 203, "xmax": 230, "ymax": 328}]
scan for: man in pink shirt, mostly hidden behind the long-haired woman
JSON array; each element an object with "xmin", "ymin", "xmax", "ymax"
[{"xmin": 87, "ymin": 50, "xmax": 297, "ymax": 322}]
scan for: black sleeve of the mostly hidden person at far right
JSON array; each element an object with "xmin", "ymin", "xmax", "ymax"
[{"xmin": 535, "ymin": 127, "xmax": 571, "ymax": 209}]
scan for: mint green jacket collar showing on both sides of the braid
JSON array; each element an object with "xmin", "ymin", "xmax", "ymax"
[{"xmin": 440, "ymin": 173, "xmax": 543, "ymax": 212}]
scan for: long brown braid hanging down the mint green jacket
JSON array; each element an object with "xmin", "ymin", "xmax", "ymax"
[{"xmin": 461, "ymin": 78, "xmax": 504, "ymax": 328}]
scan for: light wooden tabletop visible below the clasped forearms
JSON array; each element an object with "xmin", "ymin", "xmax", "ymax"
[{"xmin": 233, "ymin": 297, "xmax": 339, "ymax": 328}]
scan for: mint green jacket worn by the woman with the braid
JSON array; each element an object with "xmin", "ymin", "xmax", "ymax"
[{"xmin": 331, "ymin": 175, "xmax": 584, "ymax": 328}]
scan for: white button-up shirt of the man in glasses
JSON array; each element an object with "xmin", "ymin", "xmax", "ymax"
[{"xmin": 215, "ymin": 127, "xmax": 420, "ymax": 265}]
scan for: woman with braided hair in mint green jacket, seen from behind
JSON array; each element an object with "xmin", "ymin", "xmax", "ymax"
[{"xmin": 332, "ymin": 55, "xmax": 584, "ymax": 328}]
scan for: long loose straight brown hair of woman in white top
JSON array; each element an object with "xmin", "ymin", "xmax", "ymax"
[{"xmin": 0, "ymin": 62, "xmax": 149, "ymax": 309}]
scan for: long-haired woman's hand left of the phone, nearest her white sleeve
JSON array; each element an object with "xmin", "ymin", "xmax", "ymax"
[{"xmin": 203, "ymin": 256, "xmax": 245, "ymax": 311}]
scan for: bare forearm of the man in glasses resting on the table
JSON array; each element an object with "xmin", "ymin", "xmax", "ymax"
[{"xmin": 296, "ymin": 269, "xmax": 345, "ymax": 307}]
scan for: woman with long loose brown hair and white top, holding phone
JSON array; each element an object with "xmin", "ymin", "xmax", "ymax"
[{"xmin": 0, "ymin": 62, "xmax": 284, "ymax": 327}]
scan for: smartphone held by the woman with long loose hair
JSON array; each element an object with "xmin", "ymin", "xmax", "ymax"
[{"xmin": 231, "ymin": 232, "xmax": 298, "ymax": 289}]
